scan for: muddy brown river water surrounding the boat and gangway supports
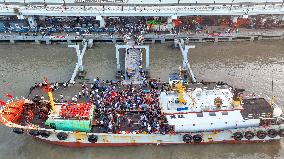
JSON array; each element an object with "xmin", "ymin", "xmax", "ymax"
[{"xmin": 0, "ymin": 41, "xmax": 284, "ymax": 159}]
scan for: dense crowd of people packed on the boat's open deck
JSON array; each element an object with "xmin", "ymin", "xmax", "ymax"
[{"xmin": 32, "ymin": 78, "xmax": 173, "ymax": 134}]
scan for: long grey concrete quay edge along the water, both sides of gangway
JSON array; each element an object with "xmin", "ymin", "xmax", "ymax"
[{"xmin": 0, "ymin": 31, "xmax": 284, "ymax": 44}]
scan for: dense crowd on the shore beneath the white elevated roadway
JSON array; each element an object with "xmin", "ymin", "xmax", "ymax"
[{"xmin": 0, "ymin": 15, "xmax": 283, "ymax": 35}]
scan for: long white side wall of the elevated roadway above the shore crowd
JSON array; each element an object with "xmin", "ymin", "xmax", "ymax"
[{"xmin": 0, "ymin": 3, "xmax": 284, "ymax": 16}]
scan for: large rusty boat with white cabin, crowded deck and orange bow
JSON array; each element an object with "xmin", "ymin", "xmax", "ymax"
[{"xmin": 0, "ymin": 74, "xmax": 284, "ymax": 147}]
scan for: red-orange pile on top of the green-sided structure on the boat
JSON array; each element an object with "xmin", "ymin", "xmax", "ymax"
[{"xmin": 59, "ymin": 103, "xmax": 92, "ymax": 120}]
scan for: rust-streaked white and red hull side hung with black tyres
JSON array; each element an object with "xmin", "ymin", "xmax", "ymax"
[{"xmin": 25, "ymin": 125, "xmax": 284, "ymax": 147}]
